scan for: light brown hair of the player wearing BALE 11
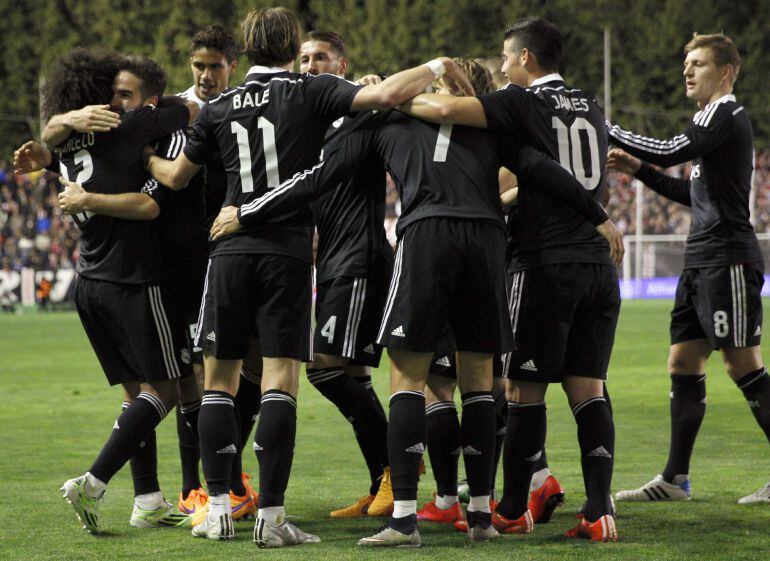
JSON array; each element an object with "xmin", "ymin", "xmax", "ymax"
[{"xmin": 241, "ymin": 7, "xmax": 302, "ymax": 66}]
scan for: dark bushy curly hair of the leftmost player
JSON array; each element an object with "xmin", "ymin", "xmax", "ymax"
[{"xmin": 41, "ymin": 47, "xmax": 123, "ymax": 119}]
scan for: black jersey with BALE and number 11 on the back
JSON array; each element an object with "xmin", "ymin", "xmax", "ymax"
[{"xmin": 184, "ymin": 66, "xmax": 361, "ymax": 263}]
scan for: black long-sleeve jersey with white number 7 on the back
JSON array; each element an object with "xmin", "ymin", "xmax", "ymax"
[{"xmin": 238, "ymin": 112, "xmax": 607, "ymax": 237}]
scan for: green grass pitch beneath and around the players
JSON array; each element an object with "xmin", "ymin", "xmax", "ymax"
[{"xmin": 0, "ymin": 301, "xmax": 770, "ymax": 561}]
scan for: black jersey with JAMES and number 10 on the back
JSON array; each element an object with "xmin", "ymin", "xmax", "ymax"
[{"xmin": 479, "ymin": 74, "xmax": 612, "ymax": 271}]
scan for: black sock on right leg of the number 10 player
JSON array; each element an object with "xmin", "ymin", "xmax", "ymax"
[{"xmin": 572, "ymin": 397, "xmax": 615, "ymax": 522}]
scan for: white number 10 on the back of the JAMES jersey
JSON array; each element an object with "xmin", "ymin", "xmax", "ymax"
[{"xmin": 551, "ymin": 117, "xmax": 602, "ymax": 191}]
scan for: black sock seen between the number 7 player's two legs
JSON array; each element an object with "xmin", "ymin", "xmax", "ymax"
[{"xmin": 425, "ymin": 401, "xmax": 462, "ymax": 497}]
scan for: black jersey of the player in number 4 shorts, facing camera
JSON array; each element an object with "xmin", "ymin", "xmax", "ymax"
[{"xmin": 310, "ymin": 112, "xmax": 394, "ymax": 283}]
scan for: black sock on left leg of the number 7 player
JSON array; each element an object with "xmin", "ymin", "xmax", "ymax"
[{"xmin": 388, "ymin": 390, "xmax": 425, "ymax": 501}]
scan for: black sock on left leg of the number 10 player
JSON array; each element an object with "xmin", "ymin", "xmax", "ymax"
[{"xmin": 497, "ymin": 401, "xmax": 546, "ymax": 520}]
